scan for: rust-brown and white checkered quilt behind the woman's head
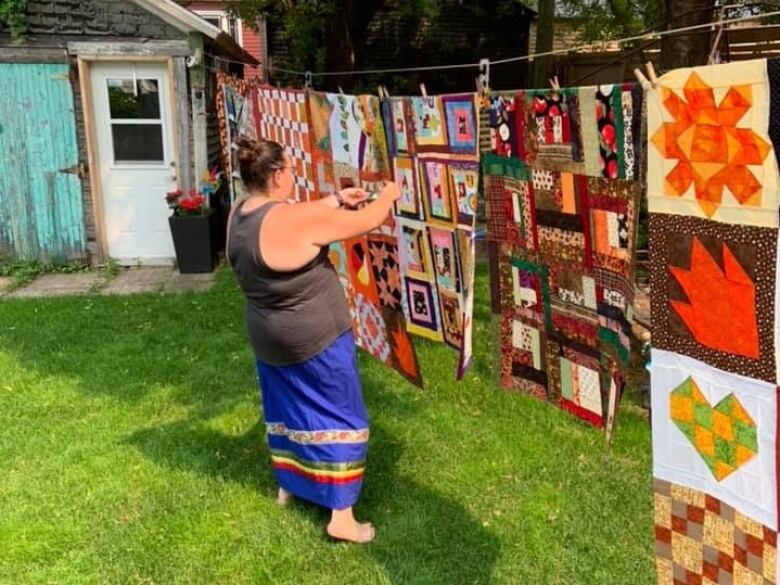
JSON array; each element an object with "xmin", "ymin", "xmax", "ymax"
[{"xmin": 256, "ymin": 86, "xmax": 319, "ymax": 201}]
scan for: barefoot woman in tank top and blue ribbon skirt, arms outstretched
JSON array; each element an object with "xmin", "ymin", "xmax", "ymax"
[{"xmin": 227, "ymin": 139, "xmax": 399, "ymax": 543}]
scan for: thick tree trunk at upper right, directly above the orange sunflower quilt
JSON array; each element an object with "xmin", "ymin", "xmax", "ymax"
[{"xmin": 661, "ymin": 0, "xmax": 715, "ymax": 71}]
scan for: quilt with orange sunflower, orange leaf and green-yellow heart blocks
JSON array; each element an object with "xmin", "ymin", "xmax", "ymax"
[{"xmin": 647, "ymin": 60, "xmax": 780, "ymax": 585}]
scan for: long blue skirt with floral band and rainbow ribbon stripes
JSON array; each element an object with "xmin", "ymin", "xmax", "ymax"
[{"xmin": 257, "ymin": 330, "xmax": 368, "ymax": 510}]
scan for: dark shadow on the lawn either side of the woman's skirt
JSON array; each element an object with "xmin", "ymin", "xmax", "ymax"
[{"xmin": 128, "ymin": 380, "xmax": 500, "ymax": 585}]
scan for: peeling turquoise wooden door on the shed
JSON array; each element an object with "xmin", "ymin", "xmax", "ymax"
[{"xmin": 0, "ymin": 63, "xmax": 86, "ymax": 263}]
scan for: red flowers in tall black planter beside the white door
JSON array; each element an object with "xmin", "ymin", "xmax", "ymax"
[{"xmin": 165, "ymin": 189, "xmax": 217, "ymax": 274}]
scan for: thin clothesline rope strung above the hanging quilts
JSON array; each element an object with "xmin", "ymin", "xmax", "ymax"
[{"xmin": 206, "ymin": 10, "xmax": 780, "ymax": 77}]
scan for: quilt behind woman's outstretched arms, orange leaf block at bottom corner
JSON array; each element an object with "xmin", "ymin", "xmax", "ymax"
[{"xmin": 308, "ymin": 92, "xmax": 422, "ymax": 386}]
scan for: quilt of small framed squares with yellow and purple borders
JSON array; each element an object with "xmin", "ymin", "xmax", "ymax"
[{"xmin": 382, "ymin": 93, "xmax": 479, "ymax": 379}]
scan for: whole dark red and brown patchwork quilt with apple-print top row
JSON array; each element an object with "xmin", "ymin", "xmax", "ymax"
[{"xmin": 482, "ymin": 85, "xmax": 643, "ymax": 440}]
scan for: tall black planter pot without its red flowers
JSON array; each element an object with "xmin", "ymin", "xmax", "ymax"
[{"xmin": 168, "ymin": 212, "xmax": 219, "ymax": 274}]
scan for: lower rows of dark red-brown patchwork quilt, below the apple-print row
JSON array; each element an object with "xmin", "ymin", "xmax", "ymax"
[{"xmin": 482, "ymin": 148, "xmax": 638, "ymax": 433}]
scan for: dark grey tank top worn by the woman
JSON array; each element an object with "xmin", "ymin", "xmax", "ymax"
[{"xmin": 228, "ymin": 201, "xmax": 352, "ymax": 366}]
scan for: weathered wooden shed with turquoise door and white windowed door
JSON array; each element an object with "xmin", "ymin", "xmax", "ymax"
[{"xmin": 0, "ymin": 0, "xmax": 257, "ymax": 265}]
